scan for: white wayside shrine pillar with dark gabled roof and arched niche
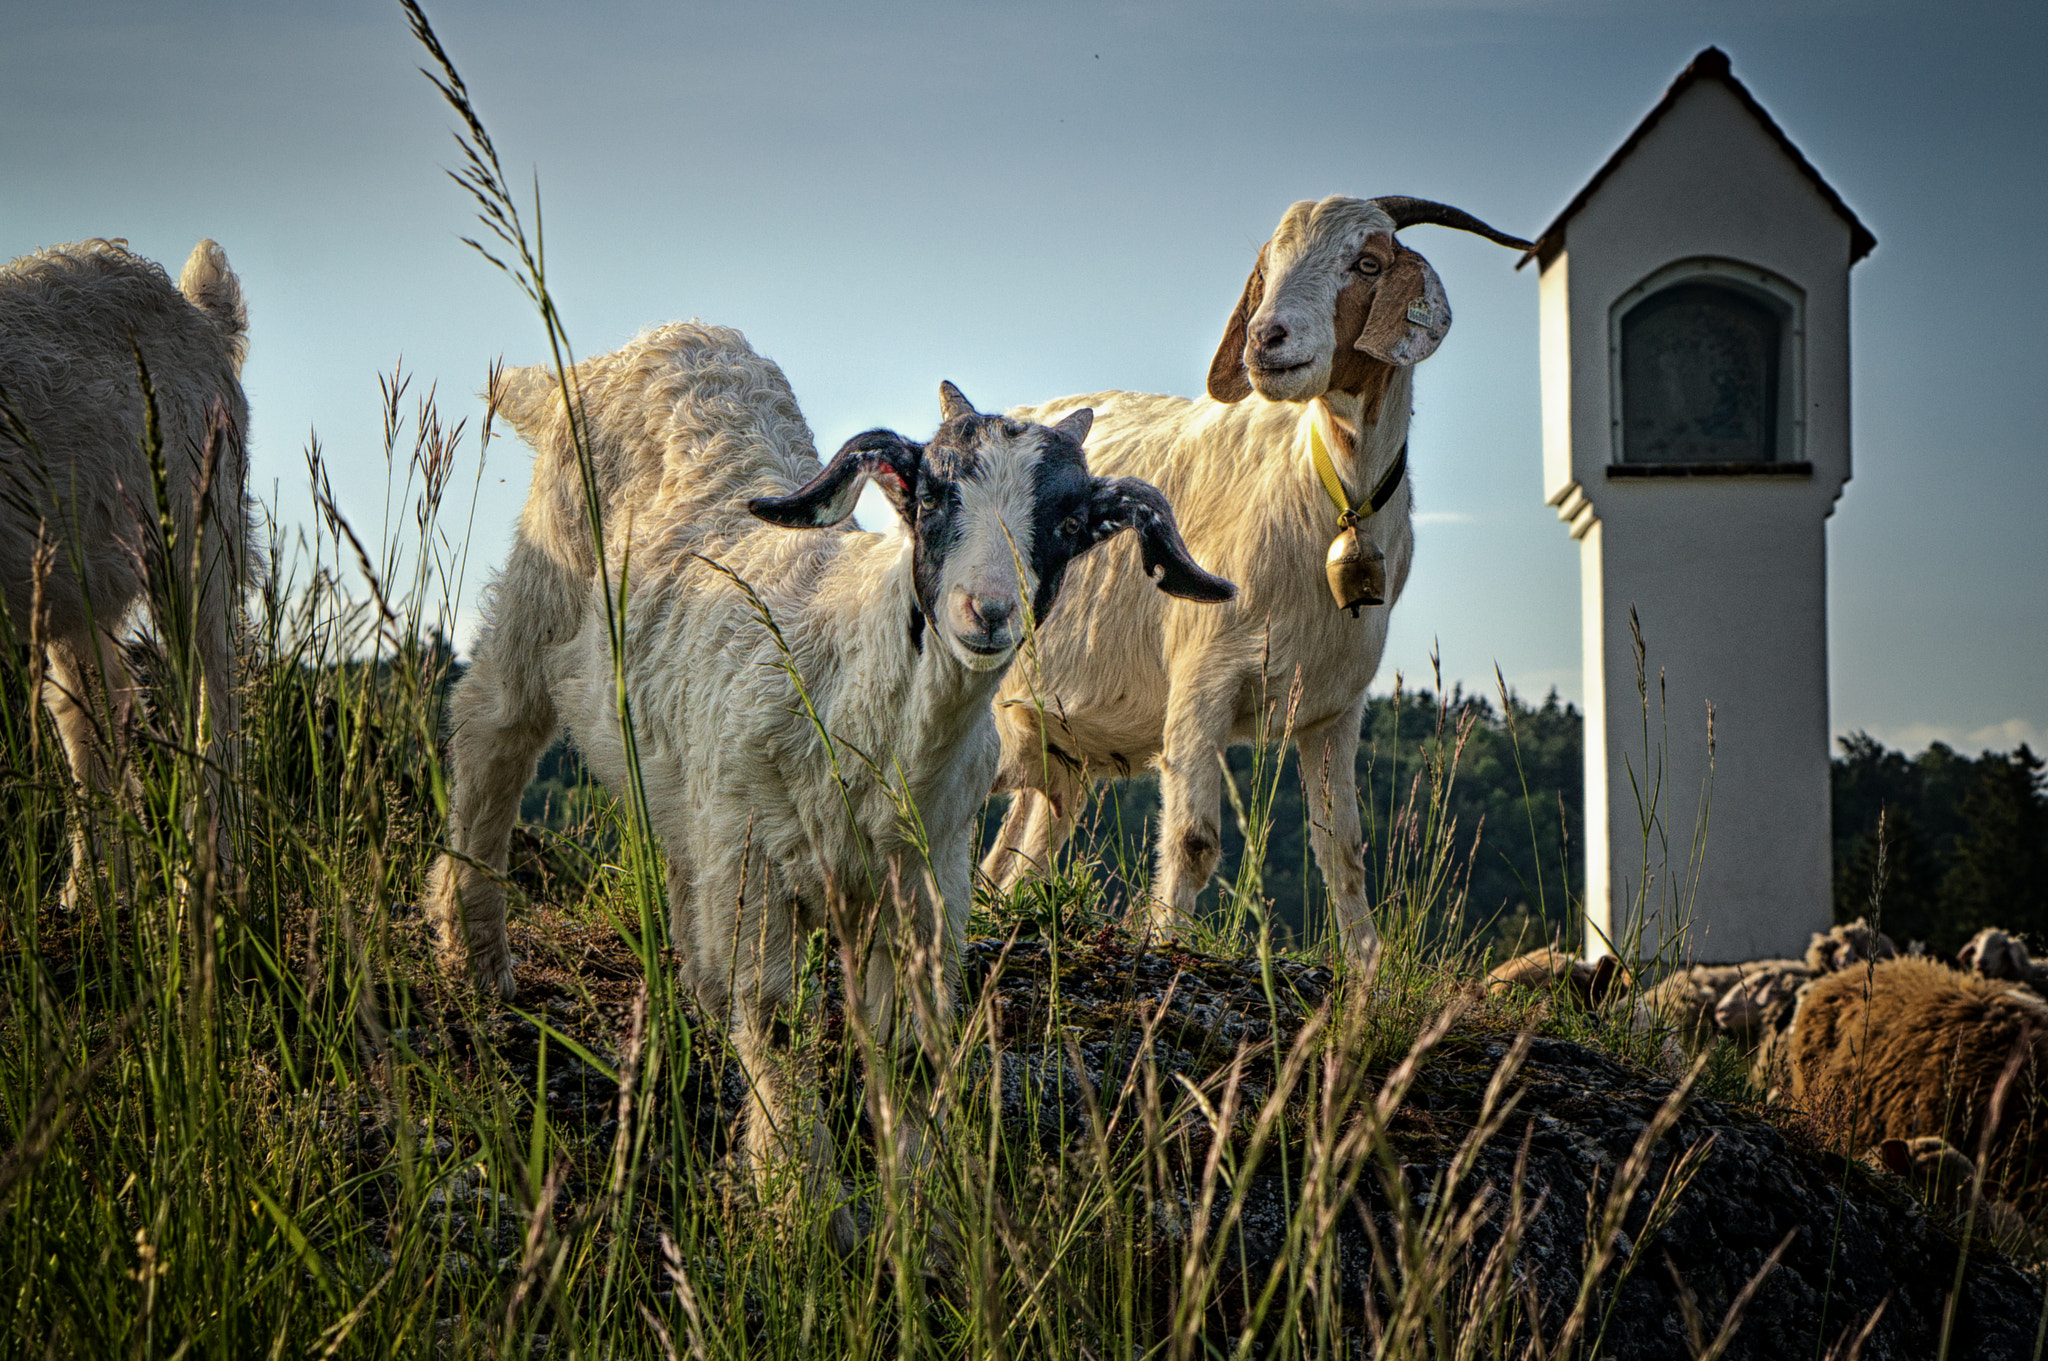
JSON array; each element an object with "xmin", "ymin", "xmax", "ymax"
[{"xmin": 1530, "ymin": 47, "xmax": 1876, "ymax": 962}]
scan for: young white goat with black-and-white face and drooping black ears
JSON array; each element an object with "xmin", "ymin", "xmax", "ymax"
[{"xmin": 430, "ymin": 323, "xmax": 1231, "ymax": 1242}]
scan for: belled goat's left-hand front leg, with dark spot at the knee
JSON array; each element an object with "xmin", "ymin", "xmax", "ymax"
[{"xmin": 1147, "ymin": 657, "xmax": 1243, "ymax": 933}]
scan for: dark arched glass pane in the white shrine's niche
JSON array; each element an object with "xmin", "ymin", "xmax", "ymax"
[{"xmin": 1622, "ymin": 282, "xmax": 1784, "ymax": 463}]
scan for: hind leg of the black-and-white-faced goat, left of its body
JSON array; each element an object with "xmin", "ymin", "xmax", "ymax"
[{"xmin": 426, "ymin": 540, "xmax": 573, "ymax": 997}]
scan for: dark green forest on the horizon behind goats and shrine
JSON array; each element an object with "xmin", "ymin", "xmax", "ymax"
[{"xmin": 522, "ymin": 686, "xmax": 2048, "ymax": 956}]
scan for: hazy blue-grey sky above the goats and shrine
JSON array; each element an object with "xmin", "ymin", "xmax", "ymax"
[{"xmin": 0, "ymin": 0, "xmax": 2048, "ymax": 749}]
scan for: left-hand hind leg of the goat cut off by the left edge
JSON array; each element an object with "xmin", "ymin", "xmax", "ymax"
[{"xmin": 43, "ymin": 630, "xmax": 135, "ymax": 909}]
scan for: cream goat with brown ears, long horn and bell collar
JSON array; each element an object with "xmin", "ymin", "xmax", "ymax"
[{"xmin": 983, "ymin": 199, "xmax": 1528, "ymax": 962}]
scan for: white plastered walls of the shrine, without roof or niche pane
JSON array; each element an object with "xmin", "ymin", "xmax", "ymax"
[{"xmin": 1540, "ymin": 80, "xmax": 1849, "ymax": 960}]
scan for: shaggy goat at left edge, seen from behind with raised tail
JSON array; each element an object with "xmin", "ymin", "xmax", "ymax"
[{"xmin": 0, "ymin": 242, "xmax": 254, "ymax": 901}]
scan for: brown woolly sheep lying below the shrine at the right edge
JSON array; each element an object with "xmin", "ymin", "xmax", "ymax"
[{"xmin": 1790, "ymin": 958, "xmax": 2048, "ymax": 1197}]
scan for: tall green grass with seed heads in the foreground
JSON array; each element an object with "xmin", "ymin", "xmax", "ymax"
[{"xmin": 0, "ymin": 6, "xmax": 1982, "ymax": 1361}]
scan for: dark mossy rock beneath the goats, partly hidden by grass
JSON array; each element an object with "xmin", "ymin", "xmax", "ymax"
[{"xmin": 365, "ymin": 900, "xmax": 2044, "ymax": 1361}]
